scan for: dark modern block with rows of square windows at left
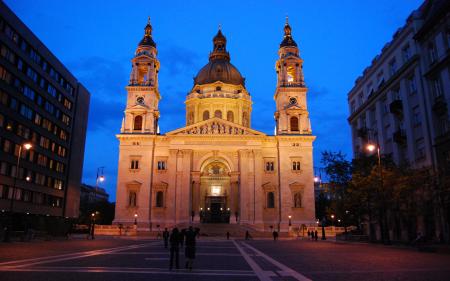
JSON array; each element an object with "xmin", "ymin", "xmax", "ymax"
[{"xmin": 0, "ymin": 2, "xmax": 90, "ymax": 218}]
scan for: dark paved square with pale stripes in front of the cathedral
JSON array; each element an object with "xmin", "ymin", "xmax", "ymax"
[{"xmin": 0, "ymin": 238, "xmax": 450, "ymax": 281}]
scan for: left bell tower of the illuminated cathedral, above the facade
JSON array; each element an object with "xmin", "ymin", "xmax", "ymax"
[{"xmin": 120, "ymin": 17, "xmax": 161, "ymax": 134}]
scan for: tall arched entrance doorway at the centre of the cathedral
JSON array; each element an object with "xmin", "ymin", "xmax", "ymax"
[{"xmin": 200, "ymin": 160, "xmax": 231, "ymax": 223}]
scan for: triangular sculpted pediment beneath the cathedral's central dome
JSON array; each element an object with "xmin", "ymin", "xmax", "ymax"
[{"xmin": 166, "ymin": 117, "xmax": 266, "ymax": 136}]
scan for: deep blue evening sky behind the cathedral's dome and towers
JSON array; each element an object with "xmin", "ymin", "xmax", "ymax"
[{"xmin": 5, "ymin": 0, "xmax": 422, "ymax": 201}]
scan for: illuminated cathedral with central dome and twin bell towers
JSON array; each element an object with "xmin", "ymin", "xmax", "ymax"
[{"xmin": 114, "ymin": 20, "xmax": 315, "ymax": 231}]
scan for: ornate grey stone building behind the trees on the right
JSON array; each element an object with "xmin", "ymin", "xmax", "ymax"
[{"xmin": 348, "ymin": 0, "xmax": 450, "ymax": 241}]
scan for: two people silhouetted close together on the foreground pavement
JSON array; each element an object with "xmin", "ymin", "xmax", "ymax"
[{"xmin": 164, "ymin": 226, "xmax": 197, "ymax": 271}]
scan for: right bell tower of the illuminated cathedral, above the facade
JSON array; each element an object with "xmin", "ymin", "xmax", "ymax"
[{"xmin": 274, "ymin": 17, "xmax": 312, "ymax": 135}]
